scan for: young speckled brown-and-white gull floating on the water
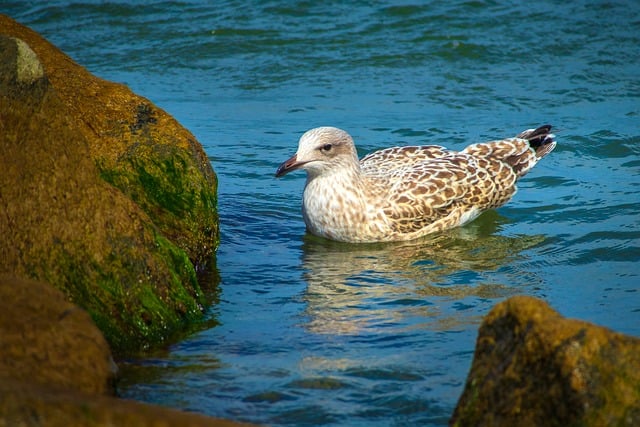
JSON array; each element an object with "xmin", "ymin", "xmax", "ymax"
[{"xmin": 276, "ymin": 125, "xmax": 556, "ymax": 242}]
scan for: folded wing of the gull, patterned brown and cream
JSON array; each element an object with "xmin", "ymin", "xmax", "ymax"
[{"xmin": 363, "ymin": 145, "xmax": 526, "ymax": 234}]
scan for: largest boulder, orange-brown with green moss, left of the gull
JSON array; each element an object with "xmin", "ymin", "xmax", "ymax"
[{"xmin": 0, "ymin": 19, "xmax": 217, "ymax": 353}]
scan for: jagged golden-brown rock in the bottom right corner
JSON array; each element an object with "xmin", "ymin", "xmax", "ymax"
[{"xmin": 450, "ymin": 296, "xmax": 640, "ymax": 426}]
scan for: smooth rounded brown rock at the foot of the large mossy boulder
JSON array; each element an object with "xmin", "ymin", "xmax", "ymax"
[{"xmin": 0, "ymin": 275, "xmax": 116, "ymax": 396}]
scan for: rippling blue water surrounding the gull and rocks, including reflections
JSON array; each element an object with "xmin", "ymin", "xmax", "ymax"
[{"xmin": 6, "ymin": 0, "xmax": 640, "ymax": 426}]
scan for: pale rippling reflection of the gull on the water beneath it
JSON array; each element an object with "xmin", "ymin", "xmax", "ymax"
[{"xmin": 302, "ymin": 212, "xmax": 546, "ymax": 334}]
